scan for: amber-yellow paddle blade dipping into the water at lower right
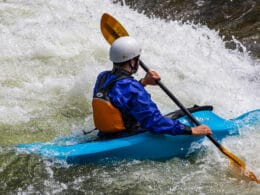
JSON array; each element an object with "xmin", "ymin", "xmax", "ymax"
[{"xmin": 220, "ymin": 146, "xmax": 260, "ymax": 184}]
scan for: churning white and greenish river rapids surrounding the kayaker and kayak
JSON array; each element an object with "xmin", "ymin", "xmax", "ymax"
[{"xmin": 0, "ymin": 0, "xmax": 260, "ymax": 194}]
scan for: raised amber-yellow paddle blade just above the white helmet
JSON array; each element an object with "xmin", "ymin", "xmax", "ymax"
[{"xmin": 100, "ymin": 13, "xmax": 128, "ymax": 45}]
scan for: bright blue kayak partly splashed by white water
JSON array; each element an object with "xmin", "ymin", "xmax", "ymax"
[{"xmin": 16, "ymin": 106, "xmax": 260, "ymax": 164}]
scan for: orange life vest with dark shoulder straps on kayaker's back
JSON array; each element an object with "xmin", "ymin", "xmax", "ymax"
[{"xmin": 92, "ymin": 74, "xmax": 127, "ymax": 133}]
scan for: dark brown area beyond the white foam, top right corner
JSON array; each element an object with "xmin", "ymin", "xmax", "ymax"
[{"xmin": 114, "ymin": 0, "xmax": 260, "ymax": 58}]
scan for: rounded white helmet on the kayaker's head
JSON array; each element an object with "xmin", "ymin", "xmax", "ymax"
[{"xmin": 109, "ymin": 36, "xmax": 142, "ymax": 63}]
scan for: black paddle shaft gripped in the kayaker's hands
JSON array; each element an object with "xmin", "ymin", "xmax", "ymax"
[{"xmin": 139, "ymin": 60, "xmax": 221, "ymax": 148}]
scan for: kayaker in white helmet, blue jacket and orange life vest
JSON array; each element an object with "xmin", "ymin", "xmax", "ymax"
[{"xmin": 92, "ymin": 36, "xmax": 212, "ymax": 139}]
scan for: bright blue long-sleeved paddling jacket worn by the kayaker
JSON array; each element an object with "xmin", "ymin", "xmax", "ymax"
[{"xmin": 94, "ymin": 71, "xmax": 190, "ymax": 135}]
